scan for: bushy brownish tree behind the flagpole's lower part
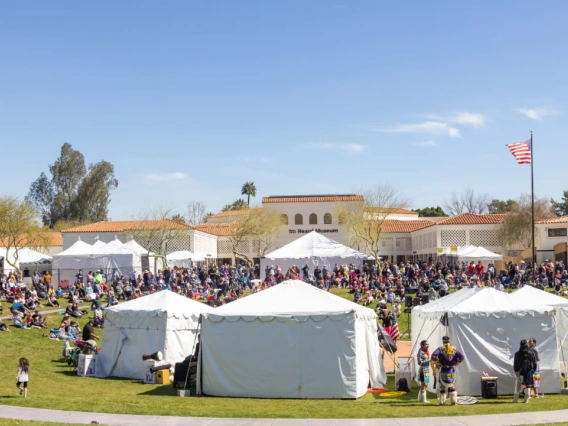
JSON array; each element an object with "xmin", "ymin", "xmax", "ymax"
[{"xmin": 499, "ymin": 194, "xmax": 556, "ymax": 249}]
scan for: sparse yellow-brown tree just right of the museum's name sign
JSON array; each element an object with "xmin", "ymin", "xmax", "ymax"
[{"xmin": 338, "ymin": 185, "xmax": 409, "ymax": 264}]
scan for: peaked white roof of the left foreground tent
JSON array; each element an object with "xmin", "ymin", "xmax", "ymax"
[{"xmin": 107, "ymin": 290, "xmax": 214, "ymax": 318}]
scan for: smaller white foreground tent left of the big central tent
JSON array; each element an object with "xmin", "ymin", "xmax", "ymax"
[{"xmin": 96, "ymin": 290, "xmax": 213, "ymax": 379}]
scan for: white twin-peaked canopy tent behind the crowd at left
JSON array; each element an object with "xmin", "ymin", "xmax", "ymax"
[{"xmin": 53, "ymin": 239, "xmax": 142, "ymax": 285}]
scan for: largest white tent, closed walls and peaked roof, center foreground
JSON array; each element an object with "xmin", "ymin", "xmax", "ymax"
[{"xmin": 197, "ymin": 280, "xmax": 386, "ymax": 398}]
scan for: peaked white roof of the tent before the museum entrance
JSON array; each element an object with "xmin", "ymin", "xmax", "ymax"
[{"xmin": 264, "ymin": 231, "xmax": 368, "ymax": 259}]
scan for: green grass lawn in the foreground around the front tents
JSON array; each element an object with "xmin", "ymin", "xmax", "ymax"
[{"xmin": 0, "ymin": 306, "xmax": 568, "ymax": 424}]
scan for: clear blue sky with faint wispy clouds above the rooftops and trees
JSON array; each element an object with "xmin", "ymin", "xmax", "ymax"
[{"xmin": 0, "ymin": 0, "xmax": 568, "ymax": 220}]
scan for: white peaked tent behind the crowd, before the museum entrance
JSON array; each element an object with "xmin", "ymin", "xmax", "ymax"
[{"xmin": 260, "ymin": 231, "xmax": 368, "ymax": 274}]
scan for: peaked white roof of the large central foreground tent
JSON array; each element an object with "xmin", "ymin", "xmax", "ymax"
[{"xmin": 213, "ymin": 280, "xmax": 377, "ymax": 321}]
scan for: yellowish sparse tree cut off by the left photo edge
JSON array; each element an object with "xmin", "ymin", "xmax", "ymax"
[{"xmin": 0, "ymin": 196, "xmax": 47, "ymax": 272}]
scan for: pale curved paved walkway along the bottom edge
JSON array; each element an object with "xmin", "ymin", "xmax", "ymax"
[{"xmin": 0, "ymin": 405, "xmax": 568, "ymax": 426}]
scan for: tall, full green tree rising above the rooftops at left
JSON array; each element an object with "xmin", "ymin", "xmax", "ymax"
[{"xmin": 26, "ymin": 143, "xmax": 118, "ymax": 227}]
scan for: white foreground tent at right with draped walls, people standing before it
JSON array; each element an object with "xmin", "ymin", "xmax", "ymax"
[{"xmin": 411, "ymin": 288, "xmax": 560, "ymax": 395}]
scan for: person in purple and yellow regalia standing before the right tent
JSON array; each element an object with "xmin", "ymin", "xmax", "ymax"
[{"xmin": 431, "ymin": 336, "xmax": 465, "ymax": 405}]
